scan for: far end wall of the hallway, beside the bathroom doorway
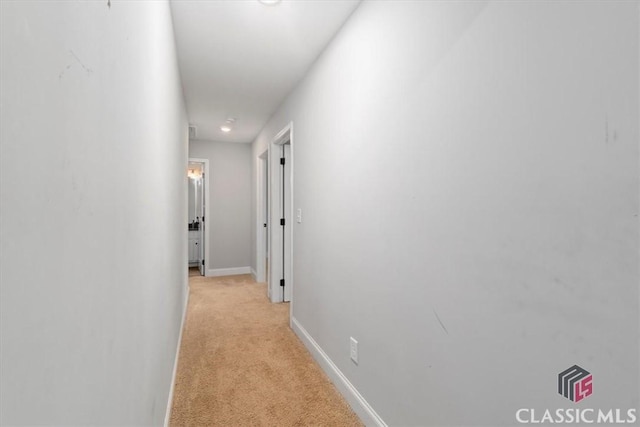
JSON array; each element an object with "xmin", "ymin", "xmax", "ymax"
[{"xmin": 189, "ymin": 141, "xmax": 251, "ymax": 275}]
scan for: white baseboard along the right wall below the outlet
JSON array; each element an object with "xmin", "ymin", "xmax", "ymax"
[{"xmin": 291, "ymin": 316, "xmax": 387, "ymax": 427}]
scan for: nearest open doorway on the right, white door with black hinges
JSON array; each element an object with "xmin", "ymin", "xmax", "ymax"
[{"xmin": 268, "ymin": 123, "xmax": 294, "ymax": 302}]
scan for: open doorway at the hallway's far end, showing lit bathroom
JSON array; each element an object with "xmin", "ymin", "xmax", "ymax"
[{"xmin": 187, "ymin": 158, "xmax": 209, "ymax": 276}]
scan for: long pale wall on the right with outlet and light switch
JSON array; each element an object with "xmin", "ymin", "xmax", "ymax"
[{"xmin": 253, "ymin": 1, "xmax": 639, "ymax": 426}]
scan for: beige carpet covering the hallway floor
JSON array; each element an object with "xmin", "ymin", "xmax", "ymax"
[{"xmin": 171, "ymin": 275, "xmax": 363, "ymax": 427}]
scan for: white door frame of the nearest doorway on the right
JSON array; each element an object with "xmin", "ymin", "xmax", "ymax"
[{"xmin": 268, "ymin": 122, "xmax": 295, "ymax": 310}]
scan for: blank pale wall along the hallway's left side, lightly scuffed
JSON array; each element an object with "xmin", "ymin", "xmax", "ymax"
[{"xmin": 0, "ymin": 1, "xmax": 188, "ymax": 426}]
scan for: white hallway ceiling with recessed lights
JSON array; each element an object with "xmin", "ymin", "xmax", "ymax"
[{"xmin": 171, "ymin": 0, "xmax": 360, "ymax": 142}]
